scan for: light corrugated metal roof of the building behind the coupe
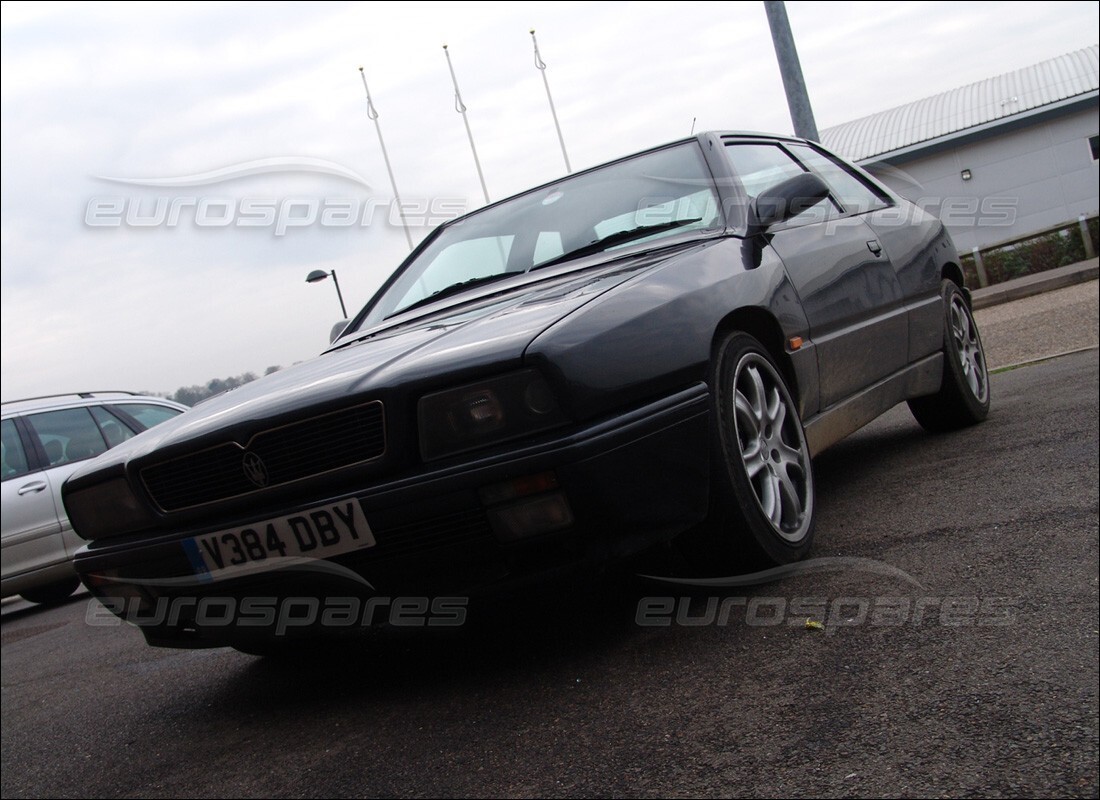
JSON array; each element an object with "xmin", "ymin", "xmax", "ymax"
[{"xmin": 821, "ymin": 45, "xmax": 1100, "ymax": 161}]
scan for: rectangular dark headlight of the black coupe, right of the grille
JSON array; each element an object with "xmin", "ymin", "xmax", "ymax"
[{"xmin": 417, "ymin": 370, "xmax": 565, "ymax": 460}]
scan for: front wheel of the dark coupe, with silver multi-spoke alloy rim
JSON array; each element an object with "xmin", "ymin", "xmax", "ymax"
[{"xmin": 684, "ymin": 331, "xmax": 815, "ymax": 571}]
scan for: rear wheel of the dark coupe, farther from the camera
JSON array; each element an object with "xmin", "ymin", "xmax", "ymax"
[{"xmin": 909, "ymin": 281, "xmax": 989, "ymax": 431}]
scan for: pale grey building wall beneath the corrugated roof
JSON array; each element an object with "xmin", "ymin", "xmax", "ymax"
[{"xmin": 866, "ymin": 106, "xmax": 1100, "ymax": 252}]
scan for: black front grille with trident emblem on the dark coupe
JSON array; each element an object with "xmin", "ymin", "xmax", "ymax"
[{"xmin": 141, "ymin": 401, "xmax": 386, "ymax": 512}]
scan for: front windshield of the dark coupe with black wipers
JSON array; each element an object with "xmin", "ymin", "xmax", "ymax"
[{"xmin": 356, "ymin": 142, "xmax": 722, "ymax": 328}]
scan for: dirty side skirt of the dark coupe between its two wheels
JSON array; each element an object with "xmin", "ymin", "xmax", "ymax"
[{"xmin": 805, "ymin": 352, "xmax": 944, "ymax": 456}]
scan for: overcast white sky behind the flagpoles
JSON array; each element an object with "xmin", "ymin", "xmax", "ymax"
[{"xmin": 0, "ymin": 0, "xmax": 1100, "ymax": 399}]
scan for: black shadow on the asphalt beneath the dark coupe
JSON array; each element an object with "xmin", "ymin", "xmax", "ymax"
[{"xmin": 204, "ymin": 539, "xmax": 910, "ymax": 725}]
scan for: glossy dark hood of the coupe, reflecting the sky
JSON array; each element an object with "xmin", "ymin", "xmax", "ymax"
[{"xmin": 73, "ymin": 248, "xmax": 701, "ymax": 474}]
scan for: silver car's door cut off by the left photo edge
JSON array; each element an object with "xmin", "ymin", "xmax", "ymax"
[{"xmin": 0, "ymin": 418, "xmax": 65, "ymax": 581}]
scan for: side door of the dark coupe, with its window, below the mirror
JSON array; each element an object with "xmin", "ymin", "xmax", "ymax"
[{"xmin": 726, "ymin": 142, "xmax": 909, "ymax": 409}]
